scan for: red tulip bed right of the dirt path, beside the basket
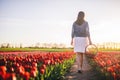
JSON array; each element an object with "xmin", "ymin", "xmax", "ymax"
[{"xmin": 87, "ymin": 51, "xmax": 120, "ymax": 80}]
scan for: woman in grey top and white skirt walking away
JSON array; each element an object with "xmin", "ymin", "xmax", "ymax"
[{"xmin": 71, "ymin": 11, "xmax": 92, "ymax": 73}]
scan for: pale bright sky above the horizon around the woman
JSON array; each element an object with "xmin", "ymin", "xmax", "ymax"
[{"xmin": 0, "ymin": 0, "xmax": 120, "ymax": 45}]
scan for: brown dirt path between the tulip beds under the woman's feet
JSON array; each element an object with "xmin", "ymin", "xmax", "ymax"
[{"xmin": 65, "ymin": 55, "xmax": 97, "ymax": 80}]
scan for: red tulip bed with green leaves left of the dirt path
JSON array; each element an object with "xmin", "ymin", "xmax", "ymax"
[{"xmin": 0, "ymin": 51, "xmax": 75, "ymax": 80}]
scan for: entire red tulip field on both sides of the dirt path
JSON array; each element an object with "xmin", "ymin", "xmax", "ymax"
[{"xmin": 0, "ymin": 47, "xmax": 120, "ymax": 80}]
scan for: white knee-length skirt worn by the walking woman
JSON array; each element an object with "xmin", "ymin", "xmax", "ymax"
[{"xmin": 74, "ymin": 37, "xmax": 88, "ymax": 53}]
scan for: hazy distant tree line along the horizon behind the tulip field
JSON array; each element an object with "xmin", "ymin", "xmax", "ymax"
[{"xmin": 0, "ymin": 42, "xmax": 120, "ymax": 49}]
